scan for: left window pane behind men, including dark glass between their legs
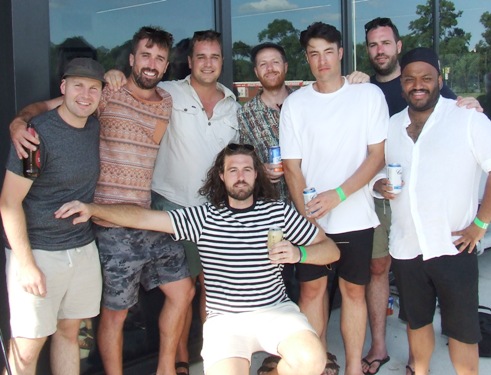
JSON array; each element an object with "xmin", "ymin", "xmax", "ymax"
[{"xmin": 49, "ymin": 0, "xmax": 215, "ymax": 374}]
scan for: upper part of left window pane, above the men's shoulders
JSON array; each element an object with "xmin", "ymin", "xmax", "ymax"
[{"xmin": 49, "ymin": 0, "xmax": 215, "ymax": 96}]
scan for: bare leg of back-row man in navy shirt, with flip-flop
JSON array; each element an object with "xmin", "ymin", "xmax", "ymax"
[{"xmin": 362, "ymin": 256, "xmax": 390, "ymax": 372}]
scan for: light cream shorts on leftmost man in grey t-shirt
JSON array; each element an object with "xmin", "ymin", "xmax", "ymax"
[{"xmin": 5, "ymin": 242, "xmax": 102, "ymax": 338}]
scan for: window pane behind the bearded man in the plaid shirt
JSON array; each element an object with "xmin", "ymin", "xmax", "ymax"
[{"xmin": 231, "ymin": 0, "xmax": 341, "ymax": 102}]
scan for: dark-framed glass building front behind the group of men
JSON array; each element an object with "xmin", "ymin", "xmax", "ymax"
[{"xmin": 0, "ymin": 0, "xmax": 491, "ymax": 374}]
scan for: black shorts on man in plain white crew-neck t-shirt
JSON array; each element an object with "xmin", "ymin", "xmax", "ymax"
[{"xmin": 296, "ymin": 228, "xmax": 373, "ymax": 285}]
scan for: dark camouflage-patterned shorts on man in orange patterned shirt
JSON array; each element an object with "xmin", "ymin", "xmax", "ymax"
[{"xmin": 95, "ymin": 225, "xmax": 189, "ymax": 310}]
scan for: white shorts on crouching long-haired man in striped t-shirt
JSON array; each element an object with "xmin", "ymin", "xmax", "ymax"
[{"xmin": 201, "ymin": 302, "xmax": 315, "ymax": 374}]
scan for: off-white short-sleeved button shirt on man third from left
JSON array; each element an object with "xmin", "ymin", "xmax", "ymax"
[{"xmin": 152, "ymin": 76, "xmax": 239, "ymax": 206}]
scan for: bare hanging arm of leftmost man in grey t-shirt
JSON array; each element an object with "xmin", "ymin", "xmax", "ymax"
[{"xmin": 0, "ymin": 171, "xmax": 46, "ymax": 297}]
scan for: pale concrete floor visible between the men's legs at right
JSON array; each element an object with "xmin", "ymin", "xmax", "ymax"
[{"xmin": 190, "ymin": 249, "xmax": 491, "ymax": 375}]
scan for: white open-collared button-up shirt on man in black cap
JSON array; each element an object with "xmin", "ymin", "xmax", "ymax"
[{"xmin": 385, "ymin": 97, "xmax": 491, "ymax": 260}]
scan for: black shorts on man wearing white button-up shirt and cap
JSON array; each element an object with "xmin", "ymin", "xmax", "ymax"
[{"xmin": 392, "ymin": 251, "xmax": 481, "ymax": 344}]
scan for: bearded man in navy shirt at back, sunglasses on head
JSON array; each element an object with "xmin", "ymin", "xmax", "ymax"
[{"xmin": 363, "ymin": 17, "xmax": 479, "ymax": 374}]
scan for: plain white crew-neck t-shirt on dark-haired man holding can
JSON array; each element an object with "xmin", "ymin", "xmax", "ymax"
[{"xmin": 280, "ymin": 81, "xmax": 389, "ymax": 233}]
